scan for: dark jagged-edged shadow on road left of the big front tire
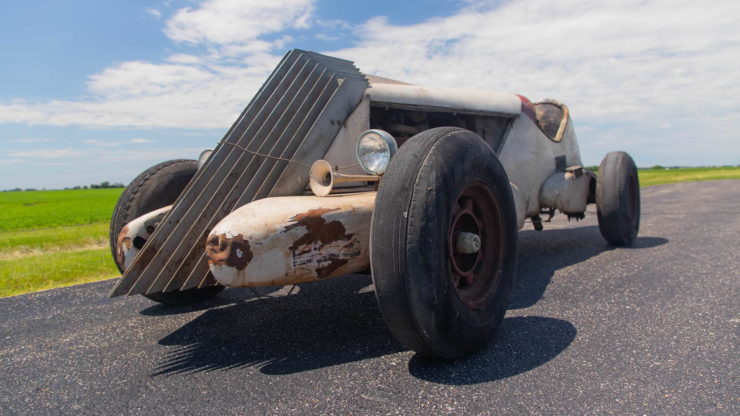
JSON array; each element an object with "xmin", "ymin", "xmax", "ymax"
[{"xmin": 153, "ymin": 275, "xmax": 406, "ymax": 376}]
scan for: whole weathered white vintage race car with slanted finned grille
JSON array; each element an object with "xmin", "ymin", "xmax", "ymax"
[{"xmin": 110, "ymin": 50, "xmax": 640, "ymax": 359}]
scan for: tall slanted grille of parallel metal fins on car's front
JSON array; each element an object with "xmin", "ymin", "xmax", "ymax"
[{"xmin": 110, "ymin": 50, "xmax": 368, "ymax": 297}]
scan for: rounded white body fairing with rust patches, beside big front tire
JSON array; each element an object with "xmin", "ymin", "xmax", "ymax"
[{"xmin": 206, "ymin": 192, "xmax": 375, "ymax": 287}]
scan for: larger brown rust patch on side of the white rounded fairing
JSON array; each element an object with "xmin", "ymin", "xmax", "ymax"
[{"xmin": 285, "ymin": 208, "xmax": 360, "ymax": 279}]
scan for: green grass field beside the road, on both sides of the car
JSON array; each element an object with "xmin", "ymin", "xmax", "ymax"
[{"xmin": 0, "ymin": 167, "xmax": 740, "ymax": 297}]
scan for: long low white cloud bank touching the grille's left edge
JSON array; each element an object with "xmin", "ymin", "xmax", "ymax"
[{"xmin": 0, "ymin": 62, "xmax": 277, "ymax": 128}]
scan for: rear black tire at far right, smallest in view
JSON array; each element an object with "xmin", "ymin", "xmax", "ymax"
[{"xmin": 596, "ymin": 152, "xmax": 640, "ymax": 246}]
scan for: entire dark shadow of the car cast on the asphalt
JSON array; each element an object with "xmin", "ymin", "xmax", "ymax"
[{"xmin": 149, "ymin": 227, "xmax": 667, "ymax": 384}]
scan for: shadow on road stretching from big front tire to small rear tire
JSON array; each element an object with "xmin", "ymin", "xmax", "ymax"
[{"xmin": 509, "ymin": 226, "xmax": 668, "ymax": 309}]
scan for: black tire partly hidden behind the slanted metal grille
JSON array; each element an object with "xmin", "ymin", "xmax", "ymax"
[{"xmin": 109, "ymin": 159, "xmax": 224, "ymax": 305}]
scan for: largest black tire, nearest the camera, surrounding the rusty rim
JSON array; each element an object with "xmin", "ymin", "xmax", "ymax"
[{"xmin": 370, "ymin": 127, "xmax": 517, "ymax": 359}]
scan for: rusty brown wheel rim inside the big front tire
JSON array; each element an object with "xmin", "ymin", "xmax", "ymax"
[{"xmin": 447, "ymin": 182, "xmax": 506, "ymax": 308}]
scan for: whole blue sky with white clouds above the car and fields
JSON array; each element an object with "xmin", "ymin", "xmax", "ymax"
[{"xmin": 0, "ymin": 0, "xmax": 740, "ymax": 189}]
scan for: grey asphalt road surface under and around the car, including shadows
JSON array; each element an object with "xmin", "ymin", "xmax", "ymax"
[{"xmin": 0, "ymin": 181, "xmax": 740, "ymax": 415}]
